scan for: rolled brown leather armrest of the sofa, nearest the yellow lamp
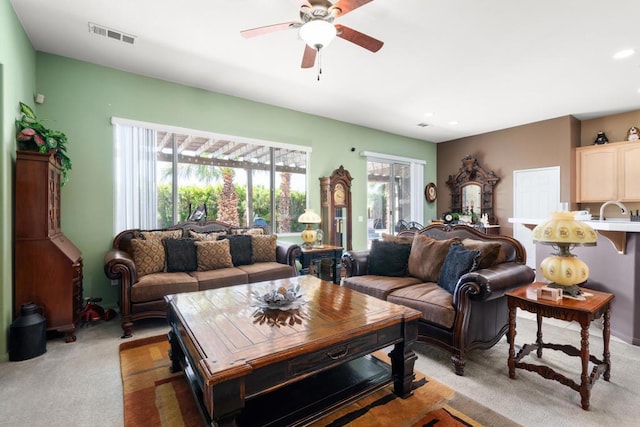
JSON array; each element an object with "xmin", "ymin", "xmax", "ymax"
[{"xmin": 453, "ymin": 262, "xmax": 535, "ymax": 306}]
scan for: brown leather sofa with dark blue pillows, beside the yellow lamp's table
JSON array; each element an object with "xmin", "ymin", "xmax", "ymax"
[{"xmin": 342, "ymin": 224, "xmax": 535, "ymax": 375}]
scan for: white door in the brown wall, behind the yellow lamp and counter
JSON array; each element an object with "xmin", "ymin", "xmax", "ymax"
[{"xmin": 513, "ymin": 166, "xmax": 560, "ymax": 269}]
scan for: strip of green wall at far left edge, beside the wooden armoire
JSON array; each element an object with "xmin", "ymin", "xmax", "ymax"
[{"xmin": 0, "ymin": 0, "xmax": 36, "ymax": 361}]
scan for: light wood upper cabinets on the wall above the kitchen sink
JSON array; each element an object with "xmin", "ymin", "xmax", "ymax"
[{"xmin": 576, "ymin": 142, "xmax": 640, "ymax": 203}]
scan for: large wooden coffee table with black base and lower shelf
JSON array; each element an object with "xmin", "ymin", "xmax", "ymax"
[{"xmin": 166, "ymin": 276, "xmax": 420, "ymax": 426}]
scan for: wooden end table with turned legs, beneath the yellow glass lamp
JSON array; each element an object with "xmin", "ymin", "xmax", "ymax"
[{"xmin": 506, "ymin": 282, "xmax": 613, "ymax": 410}]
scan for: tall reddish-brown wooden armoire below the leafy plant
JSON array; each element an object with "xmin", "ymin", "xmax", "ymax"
[{"xmin": 13, "ymin": 151, "xmax": 82, "ymax": 342}]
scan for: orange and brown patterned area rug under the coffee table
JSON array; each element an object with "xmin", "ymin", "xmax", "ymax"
[{"xmin": 120, "ymin": 336, "xmax": 518, "ymax": 427}]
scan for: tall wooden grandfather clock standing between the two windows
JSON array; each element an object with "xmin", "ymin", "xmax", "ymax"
[{"xmin": 320, "ymin": 165, "xmax": 353, "ymax": 251}]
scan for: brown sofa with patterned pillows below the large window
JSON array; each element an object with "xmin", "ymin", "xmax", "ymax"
[{"xmin": 104, "ymin": 221, "xmax": 300, "ymax": 338}]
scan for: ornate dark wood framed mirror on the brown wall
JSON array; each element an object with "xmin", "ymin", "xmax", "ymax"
[{"xmin": 447, "ymin": 156, "xmax": 500, "ymax": 224}]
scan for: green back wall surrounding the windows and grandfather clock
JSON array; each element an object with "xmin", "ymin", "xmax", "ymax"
[{"xmin": 36, "ymin": 52, "xmax": 436, "ymax": 318}]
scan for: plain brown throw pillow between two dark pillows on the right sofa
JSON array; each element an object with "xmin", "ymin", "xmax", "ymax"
[{"xmin": 409, "ymin": 233, "xmax": 460, "ymax": 283}]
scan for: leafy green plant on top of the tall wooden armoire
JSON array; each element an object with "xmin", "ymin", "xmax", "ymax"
[{"xmin": 16, "ymin": 102, "xmax": 71, "ymax": 185}]
